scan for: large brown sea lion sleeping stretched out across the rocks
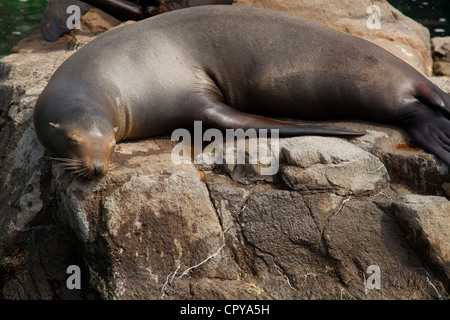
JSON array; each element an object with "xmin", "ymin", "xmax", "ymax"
[{"xmin": 34, "ymin": 6, "xmax": 450, "ymax": 176}]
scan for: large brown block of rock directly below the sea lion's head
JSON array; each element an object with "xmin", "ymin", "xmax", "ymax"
[{"xmin": 54, "ymin": 140, "xmax": 231, "ymax": 299}]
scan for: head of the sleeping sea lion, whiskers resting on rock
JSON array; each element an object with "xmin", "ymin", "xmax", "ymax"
[{"xmin": 35, "ymin": 101, "xmax": 116, "ymax": 178}]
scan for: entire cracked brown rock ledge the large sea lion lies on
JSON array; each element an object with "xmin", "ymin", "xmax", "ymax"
[{"xmin": 0, "ymin": 2, "xmax": 450, "ymax": 299}]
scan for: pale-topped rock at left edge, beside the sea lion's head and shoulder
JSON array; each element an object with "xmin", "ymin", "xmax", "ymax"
[{"xmin": 0, "ymin": 51, "xmax": 71, "ymax": 254}]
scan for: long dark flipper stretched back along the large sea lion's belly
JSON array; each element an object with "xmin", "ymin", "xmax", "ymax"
[{"xmin": 201, "ymin": 100, "xmax": 365, "ymax": 137}]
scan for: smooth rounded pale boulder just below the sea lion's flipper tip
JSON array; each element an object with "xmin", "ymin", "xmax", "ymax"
[{"xmin": 281, "ymin": 137, "xmax": 389, "ymax": 195}]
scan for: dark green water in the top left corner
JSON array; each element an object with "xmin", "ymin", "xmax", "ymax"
[{"xmin": 0, "ymin": 0, "xmax": 47, "ymax": 56}]
